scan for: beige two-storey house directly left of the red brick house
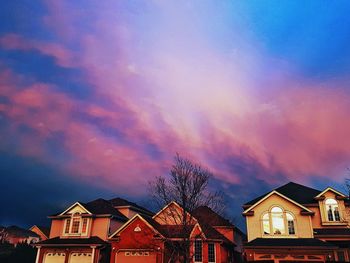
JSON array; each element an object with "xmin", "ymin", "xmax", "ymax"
[{"xmin": 36, "ymin": 198, "xmax": 152, "ymax": 263}]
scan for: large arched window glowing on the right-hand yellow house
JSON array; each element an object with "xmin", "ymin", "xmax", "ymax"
[{"xmin": 262, "ymin": 206, "xmax": 295, "ymax": 236}]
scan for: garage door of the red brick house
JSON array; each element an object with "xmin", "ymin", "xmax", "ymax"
[{"xmin": 116, "ymin": 250, "xmax": 157, "ymax": 263}]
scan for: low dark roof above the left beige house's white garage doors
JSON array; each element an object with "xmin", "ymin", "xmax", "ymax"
[{"xmin": 36, "ymin": 236, "xmax": 108, "ymax": 246}]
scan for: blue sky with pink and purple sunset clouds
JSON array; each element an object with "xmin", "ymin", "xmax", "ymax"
[{"xmin": 0, "ymin": 0, "xmax": 350, "ymax": 230}]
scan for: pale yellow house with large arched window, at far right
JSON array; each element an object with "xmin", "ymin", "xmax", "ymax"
[{"xmin": 243, "ymin": 182, "xmax": 350, "ymax": 262}]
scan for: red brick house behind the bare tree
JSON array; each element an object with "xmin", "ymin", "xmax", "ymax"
[{"xmin": 109, "ymin": 202, "xmax": 241, "ymax": 263}]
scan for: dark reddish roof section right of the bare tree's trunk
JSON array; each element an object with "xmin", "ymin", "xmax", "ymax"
[{"xmin": 192, "ymin": 206, "xmax": 233, "ymax": 227}]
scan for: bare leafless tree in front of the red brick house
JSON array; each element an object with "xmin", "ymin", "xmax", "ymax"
[{"xmin": 150, "ymin": 154, "xmax": 224, "ymax": 263}]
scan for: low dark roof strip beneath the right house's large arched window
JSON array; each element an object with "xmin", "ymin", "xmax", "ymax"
[{"xmin": 245, "ymin": 238, "xmax": 334, "ymax": 248}]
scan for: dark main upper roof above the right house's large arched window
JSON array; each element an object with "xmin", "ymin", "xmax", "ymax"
[{"xmin": 244, "ymin": 182, "xmax": 321, "ymax": 206}]
